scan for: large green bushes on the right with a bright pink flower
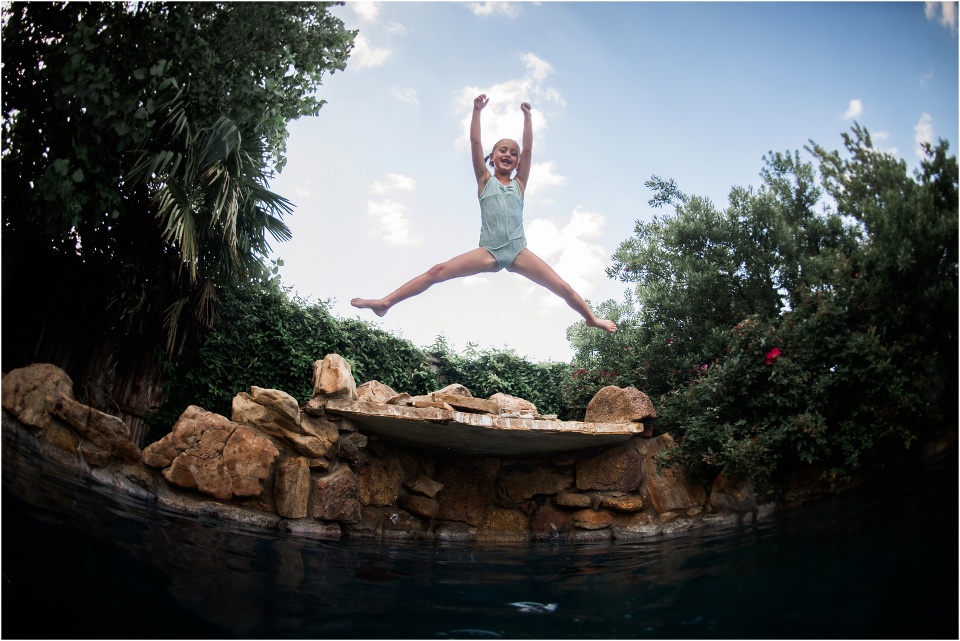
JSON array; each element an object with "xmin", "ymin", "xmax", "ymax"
[{"xmin": 569, "ymin": 126, "xmax": 958, "ymax": 489}]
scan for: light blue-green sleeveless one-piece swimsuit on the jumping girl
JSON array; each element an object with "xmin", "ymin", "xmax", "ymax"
[{"xmin": 480, "ymin": 176, "xmax": 527, "ymax": 270}]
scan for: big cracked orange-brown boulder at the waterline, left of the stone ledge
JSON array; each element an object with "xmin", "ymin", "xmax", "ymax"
[{"xmin": 143, "ymin": 405, "xmax": 280, "ymax": 500}]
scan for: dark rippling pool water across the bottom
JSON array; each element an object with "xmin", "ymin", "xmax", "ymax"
[{"xmin": 0, "ymin": 453, "xmax": 960, "ymax": 639}]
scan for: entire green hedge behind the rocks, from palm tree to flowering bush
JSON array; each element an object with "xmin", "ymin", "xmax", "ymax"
[{"xmin": 150, "ymin": 281, "xmax": 570, "ymax": 439}]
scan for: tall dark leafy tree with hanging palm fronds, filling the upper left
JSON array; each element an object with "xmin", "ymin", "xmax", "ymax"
[{"xmin": 2, "ymin": 2, "xmax": 355, "ymax": 404}]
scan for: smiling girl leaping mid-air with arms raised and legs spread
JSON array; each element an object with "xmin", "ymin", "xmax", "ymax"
[{"xmin": 350, "ymin": 94, "xmax": 617, "ymax": 333}]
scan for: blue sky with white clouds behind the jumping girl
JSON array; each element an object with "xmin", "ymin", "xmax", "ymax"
[{"xmin": 270, "ymin": 2, "xmax": 960, "ymax": 362}]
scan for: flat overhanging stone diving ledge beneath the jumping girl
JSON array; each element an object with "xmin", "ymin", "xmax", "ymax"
[{"xmin": 326, "ymin": 399, "xmax": 644, "ymax": 456}]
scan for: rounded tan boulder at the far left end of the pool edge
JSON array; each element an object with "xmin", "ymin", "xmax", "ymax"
[{"xmin": 0, "ymin": 363, "xmax": 73, "ymax": 428}]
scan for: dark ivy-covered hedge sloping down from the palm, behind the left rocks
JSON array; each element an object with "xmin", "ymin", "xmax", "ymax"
[{"xmin": 151, "ymin": 284, "xmax": 438, "ymax": 436}]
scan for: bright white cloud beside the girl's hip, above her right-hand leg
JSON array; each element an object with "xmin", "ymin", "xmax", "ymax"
[{"xmin": 525, "ymin": 207, "xmax": 608, "ymax": 310}]
